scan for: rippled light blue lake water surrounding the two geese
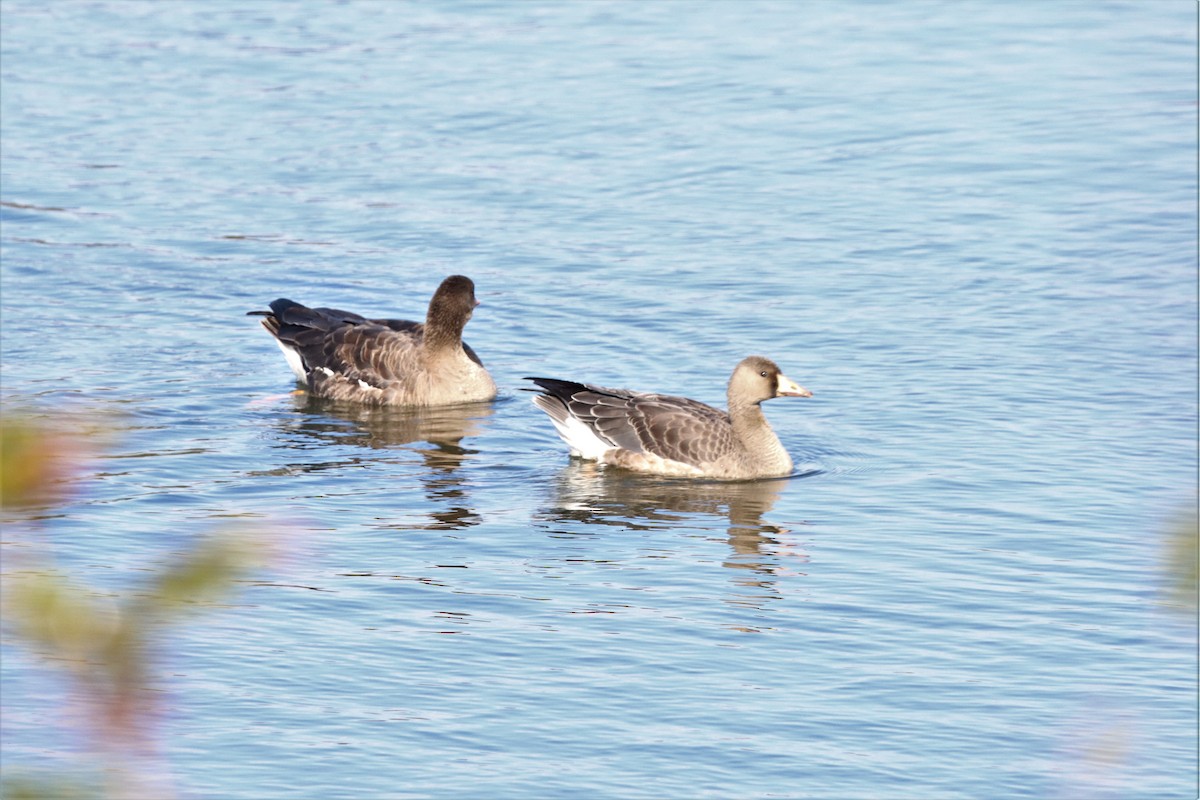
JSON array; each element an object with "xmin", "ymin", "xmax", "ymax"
[{"xmin": 0, "ymin": 0, "xmax": 1198, "ymax": 800}]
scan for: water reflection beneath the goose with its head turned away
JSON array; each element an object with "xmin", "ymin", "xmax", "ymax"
[{"xmin": 265, "ymin": 392, "xmax": 494, "ymax": 530}]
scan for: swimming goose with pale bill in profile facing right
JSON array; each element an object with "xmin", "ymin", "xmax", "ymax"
[{"xmin": 526, "ymin": 355, "xmax": 812, "ymax": 480}]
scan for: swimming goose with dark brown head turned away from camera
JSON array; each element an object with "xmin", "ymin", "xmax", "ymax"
[{"xmin": 250, "ymin": 275, "xmax": 496, "ymax": 405}]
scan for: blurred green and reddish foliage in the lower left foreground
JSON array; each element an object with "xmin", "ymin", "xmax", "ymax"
[{"xmin": 0, "ymin": 419, "xmax": 264, "ymax": 800}]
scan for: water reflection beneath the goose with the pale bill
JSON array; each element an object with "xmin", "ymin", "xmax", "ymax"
[{"xmin": 541, "ymin": 461, "xmax": 806, "ymax": 604}]
